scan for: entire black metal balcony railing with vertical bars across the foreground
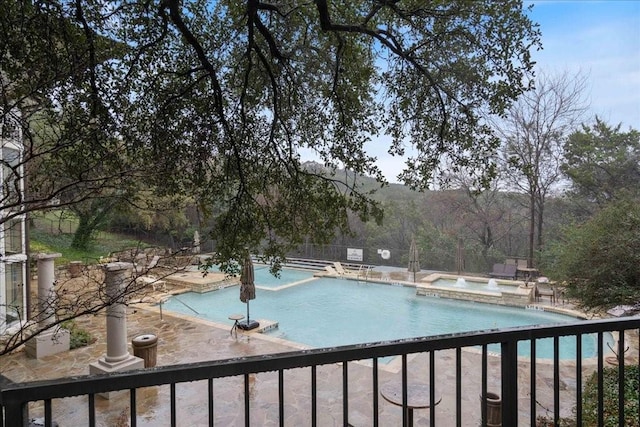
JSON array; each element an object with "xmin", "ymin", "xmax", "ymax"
[{"xmin": 0, "ymin": 317, "xmax": 640, "ymax": 427}]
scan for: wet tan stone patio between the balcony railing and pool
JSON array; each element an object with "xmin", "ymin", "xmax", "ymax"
[{"xmin": 0, "ymin": 280, "xmax": 637, "ymax": 427}]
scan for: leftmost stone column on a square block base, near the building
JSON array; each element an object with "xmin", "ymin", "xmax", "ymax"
[{"xmin": 25, "ymin": 254, "xmax": 69, "ymax": 359}]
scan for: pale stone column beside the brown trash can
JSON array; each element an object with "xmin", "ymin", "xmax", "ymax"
[{"xmin": 89, "ymin": 262, "xmax": 144, "ymax": 399}]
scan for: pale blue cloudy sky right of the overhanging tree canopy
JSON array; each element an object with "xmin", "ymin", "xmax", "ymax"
[{"xmin": 370, "ymin": 0, "xmax": 640, "ymax": 182}]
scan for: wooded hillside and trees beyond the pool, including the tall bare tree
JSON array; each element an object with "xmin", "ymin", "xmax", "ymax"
[{"xmin": 26, "ymin": 81, "xmax": 640, "ymax": 307}]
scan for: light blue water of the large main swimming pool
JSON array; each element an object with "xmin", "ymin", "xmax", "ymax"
[{"xmin": 163, "ymin": 268, "xmax": 608, "ymax": 358}]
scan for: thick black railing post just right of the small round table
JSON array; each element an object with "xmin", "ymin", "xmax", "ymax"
[{"xmin": 501, "ymin": 340, "xmax": 518, "ymax": 426}]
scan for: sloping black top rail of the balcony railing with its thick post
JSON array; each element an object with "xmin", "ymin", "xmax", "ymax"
[{"xmin": 0, "ymin": 317, "xmax": 640, "ymax": 427}]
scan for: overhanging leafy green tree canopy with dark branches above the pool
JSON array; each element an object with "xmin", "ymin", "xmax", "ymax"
[{"xmin": 0, "ymin": 0, "xmax": 540, "ymax": 260}]
